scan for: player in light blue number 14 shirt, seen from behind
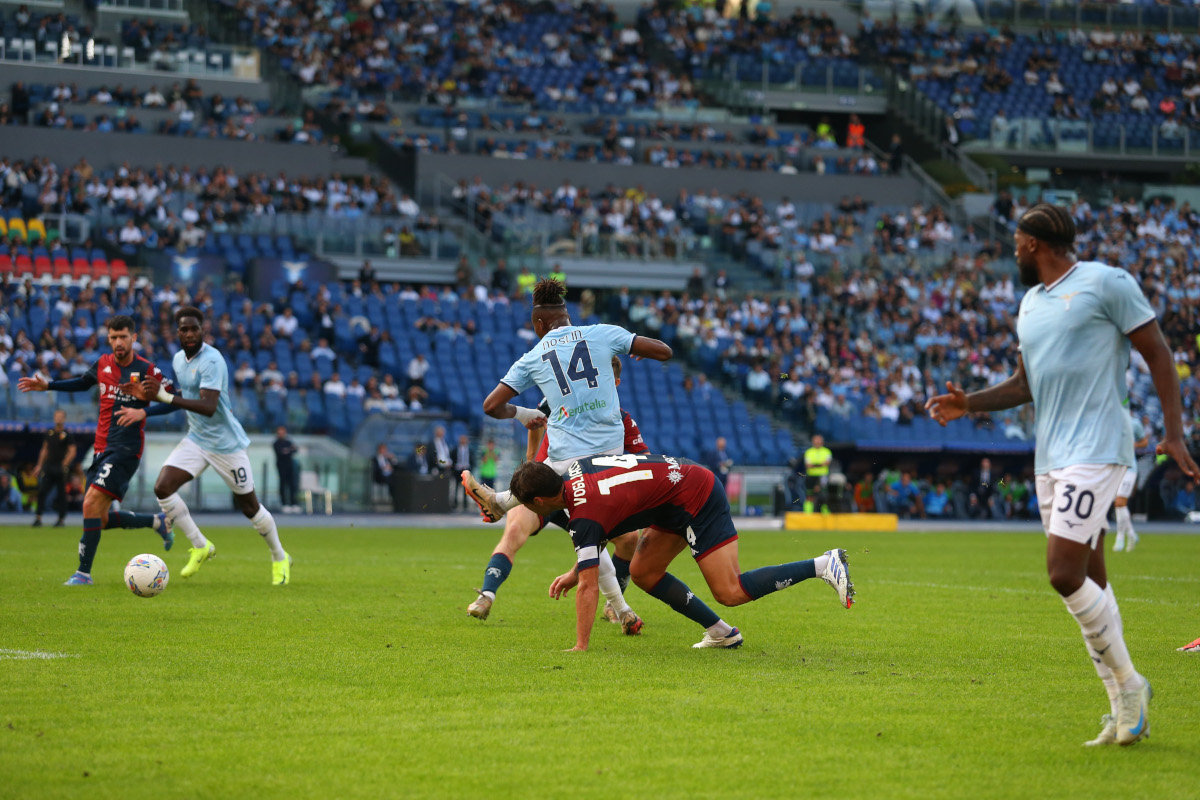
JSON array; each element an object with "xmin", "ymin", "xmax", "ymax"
[{"xmin": 462, "ymin": 278, "xmax": 671, "ymax": 631}]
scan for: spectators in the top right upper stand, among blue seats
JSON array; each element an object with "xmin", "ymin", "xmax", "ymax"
[{"xmin": 860, "ymin": 16, "xmax": 1200, "ymax": 142}]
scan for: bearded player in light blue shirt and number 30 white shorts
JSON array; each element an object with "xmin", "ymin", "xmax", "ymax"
[{"xmin": 925, "ymin": 204, "xmax": 1200, "ymax": 745}]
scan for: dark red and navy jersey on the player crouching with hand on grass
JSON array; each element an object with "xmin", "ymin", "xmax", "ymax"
[{"xmin": 563, "ymin": 453, "xmax": 714, "ymax": 570}]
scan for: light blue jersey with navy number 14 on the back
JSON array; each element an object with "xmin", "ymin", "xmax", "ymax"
[{"xmin": 500, "ymin": 325, "xmax": 636, "ymax": 461}]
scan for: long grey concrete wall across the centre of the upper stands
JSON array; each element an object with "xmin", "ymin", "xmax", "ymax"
[{"xmin": 418, "ymin": 154, "xmax": 922, "ymax": 204}]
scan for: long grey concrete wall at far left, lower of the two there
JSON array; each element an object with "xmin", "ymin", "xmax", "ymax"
[{"xmin": 0, "ymin": 125, "xmax": 367, "ymax": 176}]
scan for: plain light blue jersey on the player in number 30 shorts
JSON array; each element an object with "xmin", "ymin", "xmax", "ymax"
[{"xmin": 1016, "ymin": 261, "xmax": 1154, "ymax": 475}]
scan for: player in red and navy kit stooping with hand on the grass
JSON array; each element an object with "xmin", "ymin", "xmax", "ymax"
[{"xmin": 509, "ymin": 453, "xmax": 854, "ymax": 650}]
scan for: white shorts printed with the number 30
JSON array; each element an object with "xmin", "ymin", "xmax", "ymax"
[{"xmin": 1037, "ymin": 464, "xmax": 1128, "ymax": 549}]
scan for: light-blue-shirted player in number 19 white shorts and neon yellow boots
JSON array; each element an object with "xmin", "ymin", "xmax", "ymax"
[{"xmin": 118, "ymin": 307, "xmax": 292, "ymax": 587}]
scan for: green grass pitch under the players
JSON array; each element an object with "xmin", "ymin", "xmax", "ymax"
[{"xmin": 0, "ymin": 522, "xmax": 1200, "ymax": 800}]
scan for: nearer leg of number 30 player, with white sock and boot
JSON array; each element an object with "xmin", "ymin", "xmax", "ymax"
[{"xmin": 1046, "ymin": 534, "xmax": 1153, "ymax": 745}]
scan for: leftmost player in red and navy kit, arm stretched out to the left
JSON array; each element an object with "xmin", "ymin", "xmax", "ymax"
[{"xmin": 17, "ymin": 314, "xmax": 175, "ymax": 587}]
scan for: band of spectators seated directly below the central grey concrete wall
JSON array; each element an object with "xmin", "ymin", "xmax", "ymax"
[{"xmin": 452, "ymin": 176, "xmax": 955, "ymax": 262}]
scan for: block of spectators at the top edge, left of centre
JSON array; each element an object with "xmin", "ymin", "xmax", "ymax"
[{"xmin": 230, "ymin": 0, "xmax": 696, "ymax": 109}]
